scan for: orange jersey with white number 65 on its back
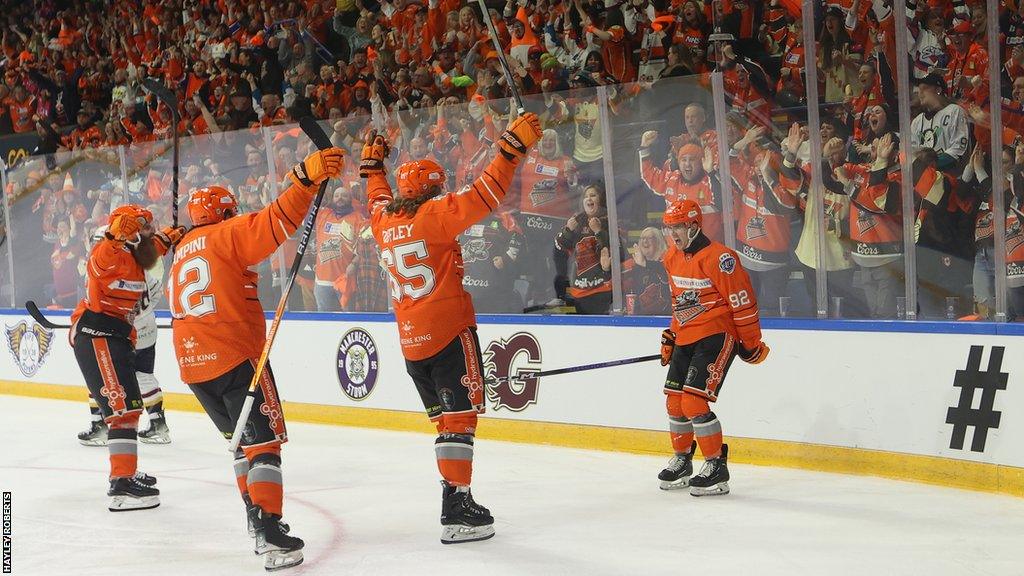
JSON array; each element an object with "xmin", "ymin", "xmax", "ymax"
[{"xmin": 367, "ymin": 154, "xmax": 517, "ymax": 360}]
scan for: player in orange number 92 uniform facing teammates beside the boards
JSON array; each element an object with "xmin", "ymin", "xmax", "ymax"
[{"xmin": 657, "ymin": 200, "xmax": 769, "ymax": 496}]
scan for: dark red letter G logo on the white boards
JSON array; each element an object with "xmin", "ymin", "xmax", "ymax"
[{"xmin": 483, "ymin": 332, "xmax": 541, "ymax": 412}]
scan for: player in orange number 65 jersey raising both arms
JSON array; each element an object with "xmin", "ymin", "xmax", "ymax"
[{"xmin": 359, "ymin": 109, "xmax": 541, "ymax": 544}]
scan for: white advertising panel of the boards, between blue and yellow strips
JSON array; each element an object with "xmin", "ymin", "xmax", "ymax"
[{"xmin": 0, "ymin": 315, "xmax": 1024, "ymax": 466}]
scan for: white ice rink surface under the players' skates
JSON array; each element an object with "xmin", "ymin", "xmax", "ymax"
[{"xmin": 0, "ymin": 396, "xmax": 1024, "ymax": 576}]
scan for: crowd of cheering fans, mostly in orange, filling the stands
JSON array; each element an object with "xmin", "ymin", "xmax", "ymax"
[{"xmin": 6, "ymin": 0, "xmax": 1024, "ymax": 318}]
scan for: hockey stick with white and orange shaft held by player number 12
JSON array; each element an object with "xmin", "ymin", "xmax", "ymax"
[{"xmin": 227, "ymin": 116, "xmax": 332, "ymax": 453}]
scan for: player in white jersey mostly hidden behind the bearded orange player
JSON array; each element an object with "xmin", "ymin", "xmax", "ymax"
[{"xmin": 78, "ymin": 227, "xmax": 171, "ymax": 446}]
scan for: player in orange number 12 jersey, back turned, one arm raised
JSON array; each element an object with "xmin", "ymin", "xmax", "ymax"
[{"xmin": 168, "ymin": 148, "xmax": 344, "ymax": 570}]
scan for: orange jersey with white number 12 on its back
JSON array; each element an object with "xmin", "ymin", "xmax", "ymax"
[{"xmin": 167, "ymin": 184, "xmax": 315, "ymax": 384}]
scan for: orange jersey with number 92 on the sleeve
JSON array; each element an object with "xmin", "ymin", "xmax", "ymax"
[{"xmin": 663, "ymin": 234, "xmax": 761, "ymax": 349}]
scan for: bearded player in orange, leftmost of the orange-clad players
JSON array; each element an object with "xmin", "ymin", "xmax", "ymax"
[{"xmin": 70, "ymin": 204, "xmax": 183, "ymax": 511}]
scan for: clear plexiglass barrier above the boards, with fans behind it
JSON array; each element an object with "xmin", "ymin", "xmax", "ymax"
[{"xmin": 0, "ymin": 5, "xmax": 1024, "ymax": 321}]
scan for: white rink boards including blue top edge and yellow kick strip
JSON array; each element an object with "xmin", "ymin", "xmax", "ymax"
[{"xmin": 0, "ymin": 311, "xmax": 1024, "ymax": 496}]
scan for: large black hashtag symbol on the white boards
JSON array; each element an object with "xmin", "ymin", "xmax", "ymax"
[{"xmin": 946, "ymin": 346, "xmax": 1010, "ymax": 452}]
